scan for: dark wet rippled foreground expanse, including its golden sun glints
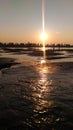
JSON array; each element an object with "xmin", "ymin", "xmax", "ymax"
[{"xmin": 0, "ymin": 47, "xmax": 73, "ymax": 130}]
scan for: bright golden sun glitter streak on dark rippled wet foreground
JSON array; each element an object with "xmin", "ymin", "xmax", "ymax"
[{"xmin": 33, "ymin": 60, "xmax": 53, "ymax": 114}]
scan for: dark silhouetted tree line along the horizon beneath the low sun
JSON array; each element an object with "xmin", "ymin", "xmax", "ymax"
[{"xmin": 0, "ymin": 42, "xmax": 73, "ymax": 48}]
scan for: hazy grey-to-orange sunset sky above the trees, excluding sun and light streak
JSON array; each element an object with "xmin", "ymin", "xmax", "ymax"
[{"xmin": 0, "ymin": 0, "xmax": 73, "ymax": 44}]
